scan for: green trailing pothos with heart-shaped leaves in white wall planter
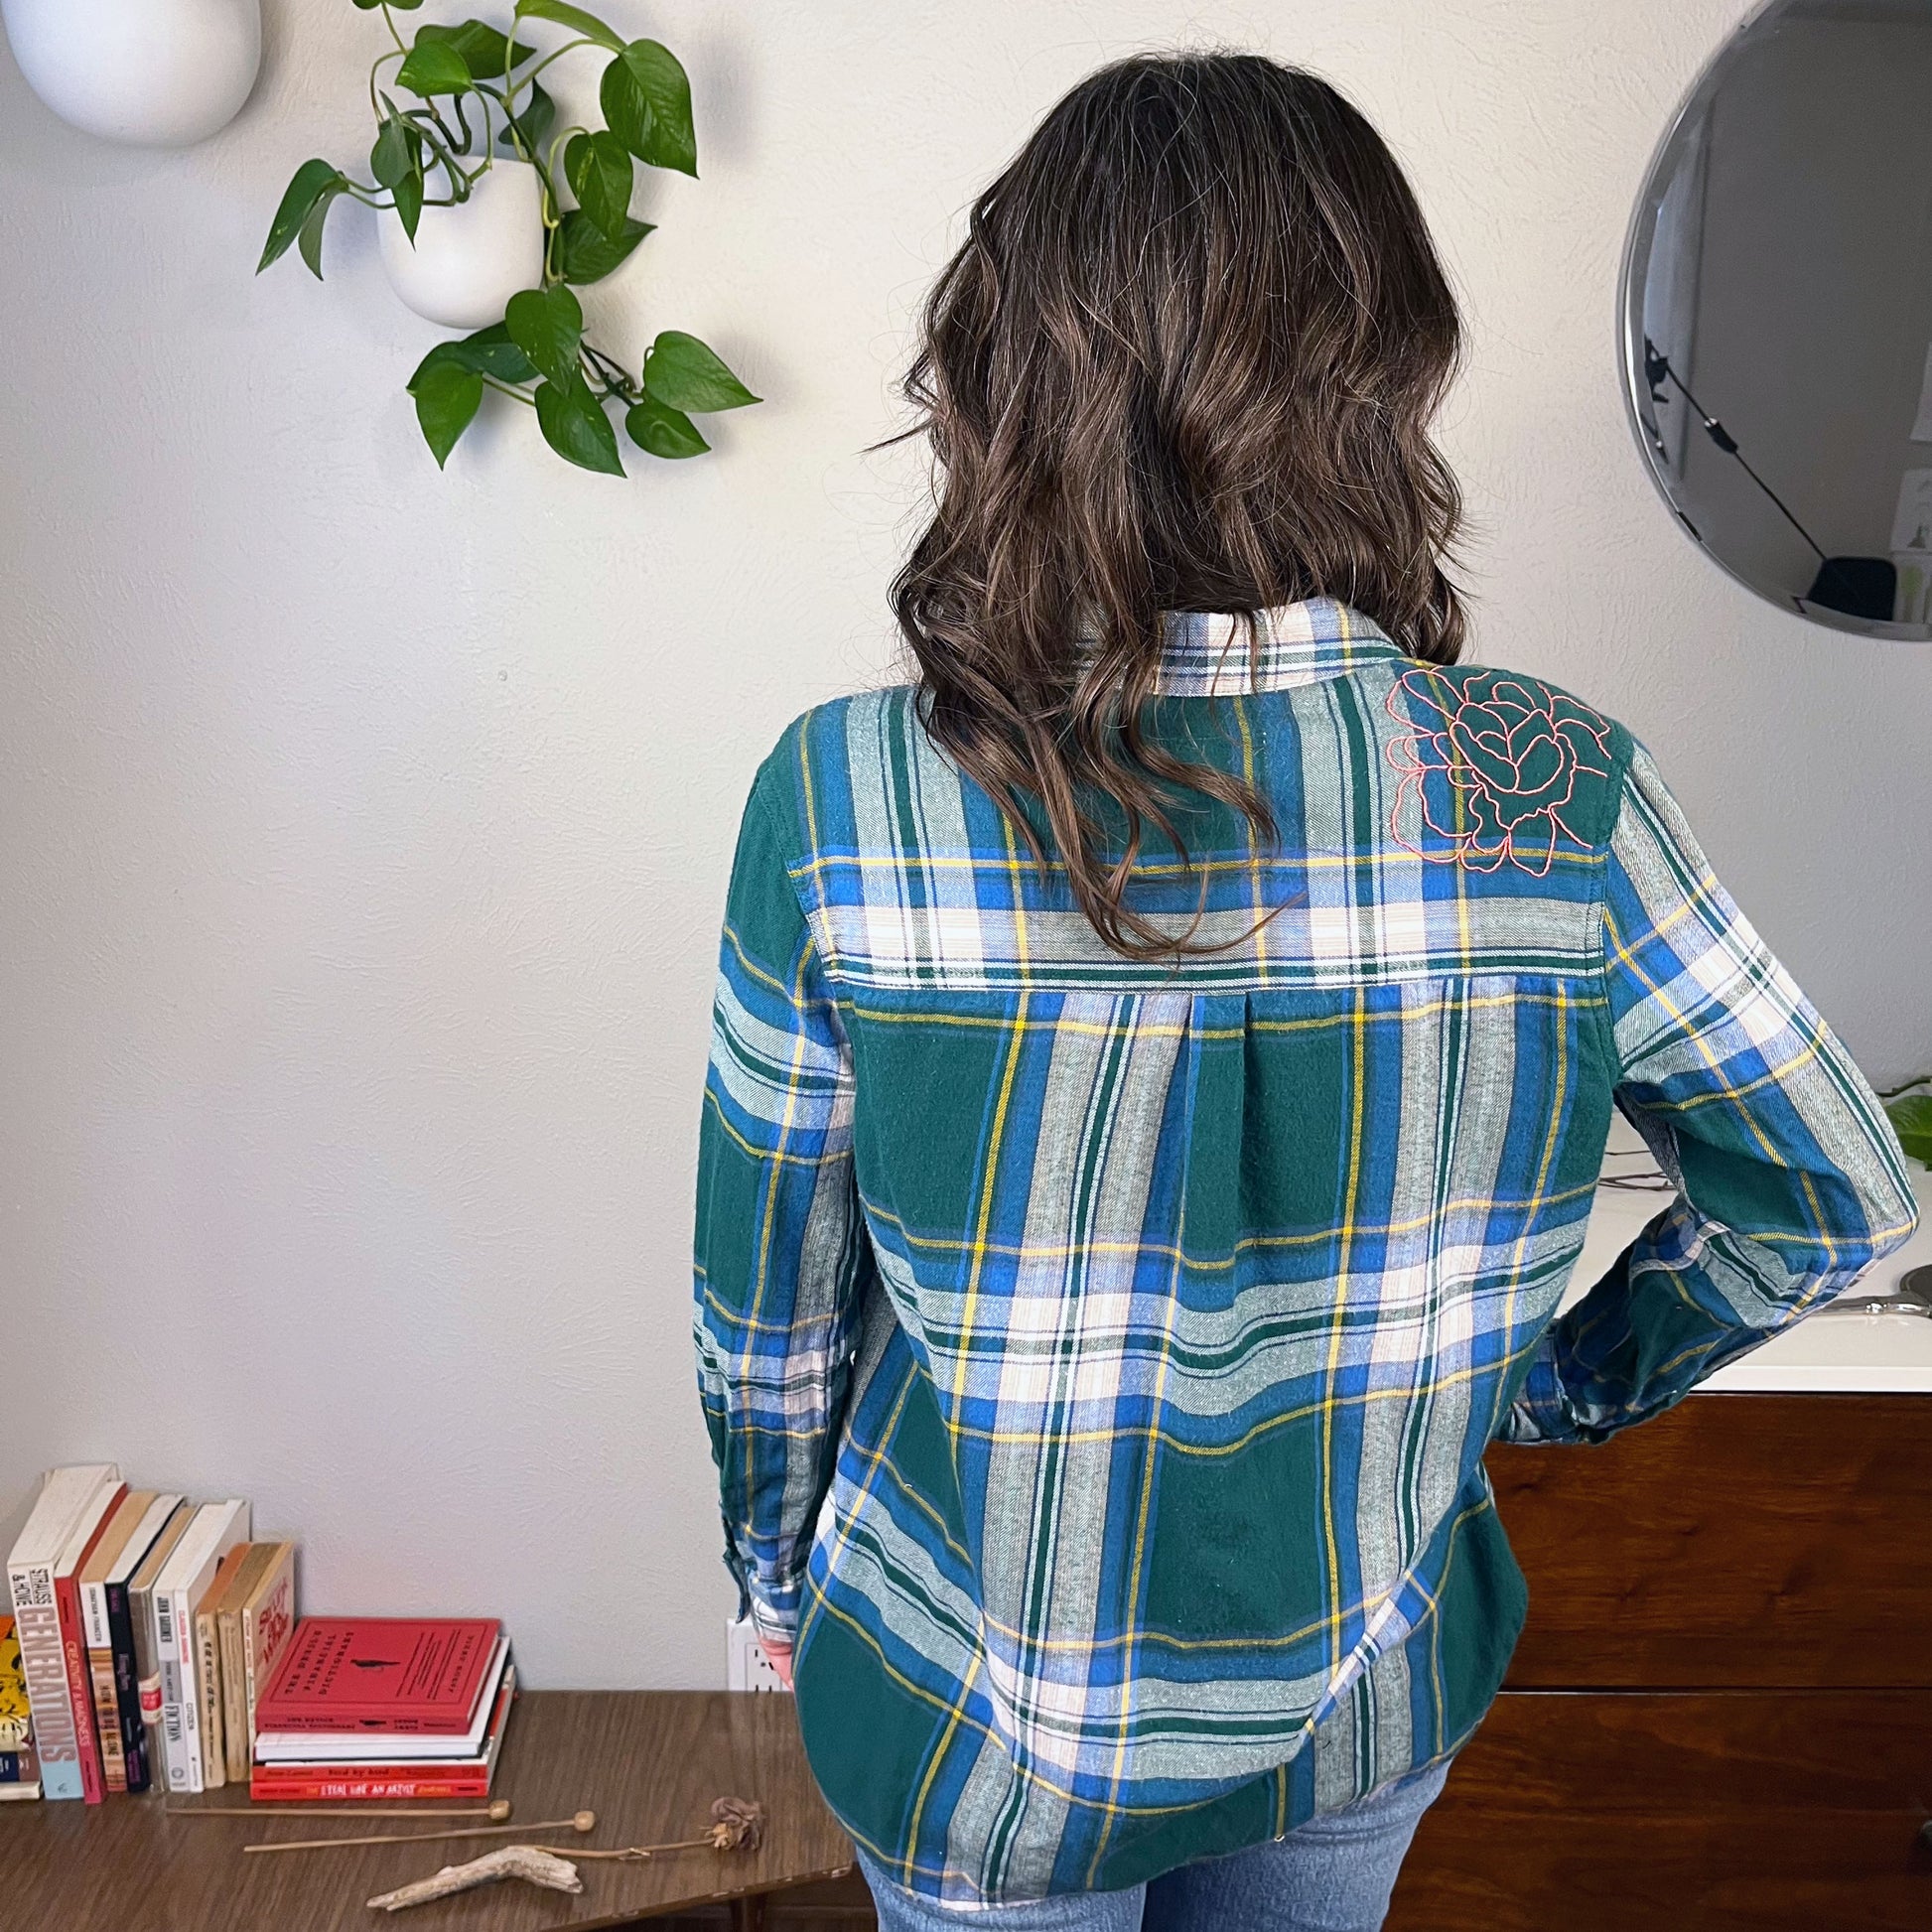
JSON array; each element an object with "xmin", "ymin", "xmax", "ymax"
[{"xmin": 255, "ymin": 0, "xmax": 759, "ymax": 476}]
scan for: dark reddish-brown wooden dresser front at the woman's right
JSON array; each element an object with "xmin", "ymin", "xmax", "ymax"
[{"xmin": 1389, "ymin": 1393, "xmax": 1932, "ymax": 1932}]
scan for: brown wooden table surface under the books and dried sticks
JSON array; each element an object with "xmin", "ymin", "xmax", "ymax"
[{"xmin": 0, "ymin": 1691, "xmax": 852, "ymax": 1932}]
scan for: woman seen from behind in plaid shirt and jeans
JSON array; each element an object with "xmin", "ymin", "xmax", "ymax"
[{"xmin": 698, "ymin": 56, "xmax": 1914, "ymax": 1932}]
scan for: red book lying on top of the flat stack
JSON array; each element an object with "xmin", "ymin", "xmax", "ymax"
[{"xmin": 255, "ymin": 1617, "xmax": 498, "ymax": 1736}]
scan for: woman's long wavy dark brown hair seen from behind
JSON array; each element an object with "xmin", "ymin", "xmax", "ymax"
[{"xmin": 893, "ymin": 54, "xmax": 1462, "ymax": 958}]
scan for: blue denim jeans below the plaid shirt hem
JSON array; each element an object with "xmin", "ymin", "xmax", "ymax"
[{"xmin": 860, "ymin": 1764, "xmax": 1449, "ymax": 1932}]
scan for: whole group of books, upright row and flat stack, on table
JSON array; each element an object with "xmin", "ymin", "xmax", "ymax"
[{"xmin": 0, "ymin": 1462, "xmax": 516, "ymax": 1805}]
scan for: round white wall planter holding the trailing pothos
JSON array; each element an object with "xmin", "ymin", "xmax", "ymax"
[{"xmin": 376, "ymin": 157, "xmax": 543, "ymax": 329}]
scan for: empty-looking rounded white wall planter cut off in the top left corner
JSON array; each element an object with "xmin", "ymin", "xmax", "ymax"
[{"xmin": 0, "ymin": 0, "xmax": 261, "ymax": 147}]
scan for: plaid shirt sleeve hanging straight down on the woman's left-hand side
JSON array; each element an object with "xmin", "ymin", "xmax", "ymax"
[{"xmin": 696, "ymin": 765, "xmax": 870, "ymax": 1642}]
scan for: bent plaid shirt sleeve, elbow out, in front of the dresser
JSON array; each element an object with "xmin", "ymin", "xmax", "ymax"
[{"xmin": 1501, "ymin": 748, "xmax": 1918, "ymax": 1442}]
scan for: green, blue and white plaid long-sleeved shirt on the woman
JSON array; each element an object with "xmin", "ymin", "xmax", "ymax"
[{"xmin": 698, "ymin": 601, "xmax": 1914, "ymax": 1905}]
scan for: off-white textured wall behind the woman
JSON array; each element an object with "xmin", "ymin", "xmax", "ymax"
[{"xmin": 0, "ymin": 0, "xmax": 1932, "ymax": 1685}]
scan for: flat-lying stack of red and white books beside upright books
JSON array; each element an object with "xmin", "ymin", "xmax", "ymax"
[{"xmin": 249, "ymin": 1617, "xmax": 516, "ymax": 1799}]
